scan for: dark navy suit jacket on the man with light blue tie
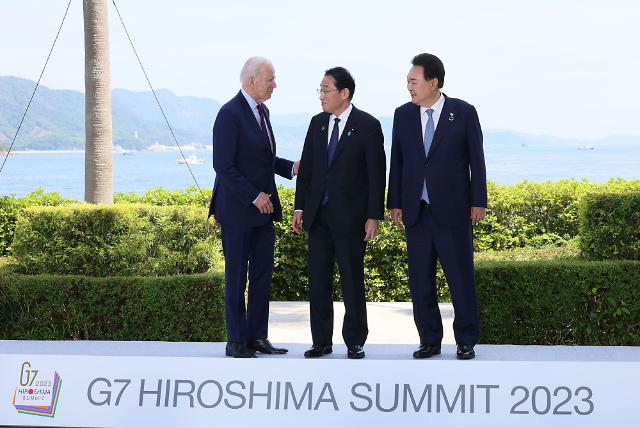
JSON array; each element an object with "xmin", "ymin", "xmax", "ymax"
[{"xmin": 387, "ymin": 94, "xmax": 487, "ymax": 226}]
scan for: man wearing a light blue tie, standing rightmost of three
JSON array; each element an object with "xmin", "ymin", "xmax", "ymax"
[{"xmin": 387, "ymin": 54, "xmax": 487, "ymax": 360}]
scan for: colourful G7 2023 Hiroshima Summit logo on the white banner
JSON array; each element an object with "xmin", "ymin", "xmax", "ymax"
[{"xmin": 12, "ymin": 361, "xmax": 62, "ymax": 418}]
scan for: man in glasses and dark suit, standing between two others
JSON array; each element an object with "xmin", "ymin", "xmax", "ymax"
[{"xmin": 292, "ymin": 67, "xmax": 386, "ymax": 359}]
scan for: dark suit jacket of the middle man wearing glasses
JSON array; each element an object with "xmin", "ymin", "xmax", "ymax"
[{"xmin": 295, "ymin": 106, "xmax": 386, "ymax": 236}]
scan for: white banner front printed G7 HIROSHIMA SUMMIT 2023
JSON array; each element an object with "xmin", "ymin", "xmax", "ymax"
[{"xmin": 0, "ymin": 348, "xmax": 640, "ymax": 428}]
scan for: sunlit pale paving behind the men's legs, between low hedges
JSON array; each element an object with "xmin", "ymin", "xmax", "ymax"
[{"xmin": 269, "ymin": 302, "xmax": 455, "ymax": 345}]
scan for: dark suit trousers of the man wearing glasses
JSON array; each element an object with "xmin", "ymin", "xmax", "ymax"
[{"xmin": 308, "ymin": 202, "xmax": 369, "ymax": 346}]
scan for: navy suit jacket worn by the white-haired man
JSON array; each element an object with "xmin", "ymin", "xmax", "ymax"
[{"xmin": 209, "ymin": 92, "xmax": 293, "ymax": 226}]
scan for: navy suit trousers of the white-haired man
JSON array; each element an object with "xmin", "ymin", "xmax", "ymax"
[{"xmin": 221, "ymin": 222, "xmax": 275, "ymax": 342}]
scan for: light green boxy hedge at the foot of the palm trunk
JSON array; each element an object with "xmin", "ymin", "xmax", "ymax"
[{"xmin": 13, "ymin": 204, "xmax": 221, "ymax": 276}]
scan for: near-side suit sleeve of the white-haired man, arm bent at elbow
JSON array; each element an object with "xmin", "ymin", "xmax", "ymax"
[{"xmin": 213, "ymin": 109, "xmax": 260, "ymax": 205}]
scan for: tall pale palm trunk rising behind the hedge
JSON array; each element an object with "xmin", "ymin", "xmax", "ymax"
[{"xmin": 83, "ymin": 0, "xmax": 113, "ymax": 204}]
